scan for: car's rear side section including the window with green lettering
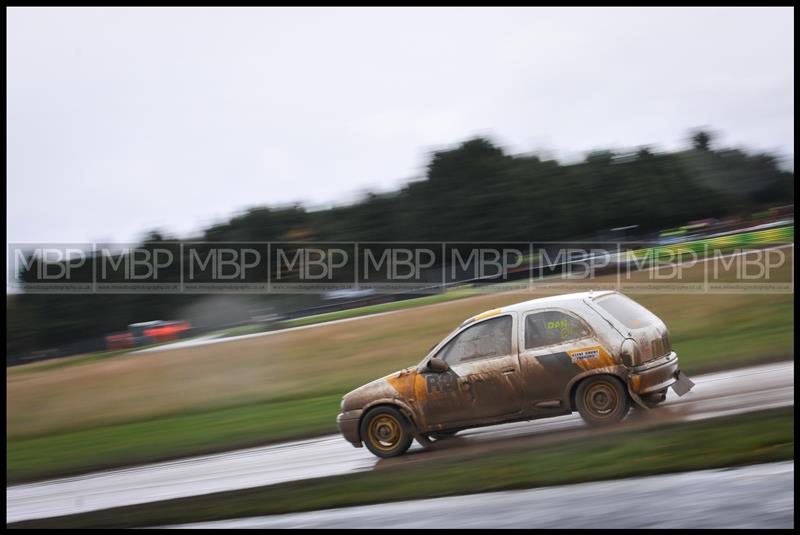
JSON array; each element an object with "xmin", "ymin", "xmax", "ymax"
[{"xmin": 518, "ymin": 308, "xmax": 614, "ymax": 414}]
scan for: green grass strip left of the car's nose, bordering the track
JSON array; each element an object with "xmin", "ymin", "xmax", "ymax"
[{"xmin": 6, "ymin": 394, "xmax": 342, "ymax": 483}]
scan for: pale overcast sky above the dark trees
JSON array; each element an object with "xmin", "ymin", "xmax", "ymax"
[{"xmin": 6, "ymin": 8, "xmax": 794, "ymax": 242}]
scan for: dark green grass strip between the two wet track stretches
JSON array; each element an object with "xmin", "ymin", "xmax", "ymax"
[{"xmin": 9, "ymin": 407, "xmax": 794, "ymax": 528}]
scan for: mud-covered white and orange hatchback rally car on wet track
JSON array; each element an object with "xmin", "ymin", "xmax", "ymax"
[{"xmin": 336, "ymin": 291, "xmax": 693, "ymax": 457}]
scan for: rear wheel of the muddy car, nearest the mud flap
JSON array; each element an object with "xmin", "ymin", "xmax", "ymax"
[{"xmin": 575, "ymin": 375, "xmax": 631, "ymax": 426}]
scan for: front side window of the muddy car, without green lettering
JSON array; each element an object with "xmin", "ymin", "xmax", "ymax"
[{"xmin": 436, "ymin": 316, "xmax": 512, "ymax": 366}]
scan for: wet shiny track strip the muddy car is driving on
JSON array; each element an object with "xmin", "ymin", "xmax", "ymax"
[{"xmin": 6, "ymin": 362, "xmax": 794, "ymax": 527}]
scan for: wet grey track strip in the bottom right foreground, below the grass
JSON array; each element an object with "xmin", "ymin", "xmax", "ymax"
[{"xmin": 173, "ymin": 462, "xmax": 794, "ymax": 529}]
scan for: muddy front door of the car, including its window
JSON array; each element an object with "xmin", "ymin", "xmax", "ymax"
[{"xmin": 423, "ymin": 313, "xmax": 523, "ymax": 428}]
